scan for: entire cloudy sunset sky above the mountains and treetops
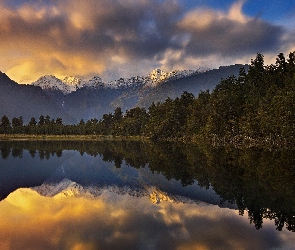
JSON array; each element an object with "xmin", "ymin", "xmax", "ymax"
[{"xmin": 0, "ymin": 0, "xmax": 295, "ymax": 83}]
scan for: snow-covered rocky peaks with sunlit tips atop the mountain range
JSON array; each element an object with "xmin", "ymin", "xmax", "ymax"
[{"xmin": 31, "ymin": 69, "xmax": 204, "ymax": 95}]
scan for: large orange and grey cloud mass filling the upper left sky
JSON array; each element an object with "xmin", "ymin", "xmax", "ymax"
[{"xmin": 0, "ymin": 0, "xmax": 179, "ymax": 80}]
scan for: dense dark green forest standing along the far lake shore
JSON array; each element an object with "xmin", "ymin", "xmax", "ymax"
[{"xmin": 0, "ymin": 52, "xmax": 295, "ymax": 145}]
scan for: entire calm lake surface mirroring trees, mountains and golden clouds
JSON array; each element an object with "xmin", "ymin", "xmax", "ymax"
[{"xmin": 0, "ymin": 141, "xmax": 295, "ymax": 249}]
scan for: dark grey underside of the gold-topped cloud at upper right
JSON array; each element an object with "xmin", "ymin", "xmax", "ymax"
[{"xmin": 180, "ymin": 16, "xmax": 284, "ymax": 57}]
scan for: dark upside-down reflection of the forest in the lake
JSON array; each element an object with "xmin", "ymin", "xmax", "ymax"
[{"xmin": 0, "ymin": 141, "xmax": 295, "ymax": 232}]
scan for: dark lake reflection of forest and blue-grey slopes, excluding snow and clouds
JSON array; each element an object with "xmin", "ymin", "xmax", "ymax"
[{"xmin": 0, "ymin": 141, "xmax": 295, "ymax": 238}]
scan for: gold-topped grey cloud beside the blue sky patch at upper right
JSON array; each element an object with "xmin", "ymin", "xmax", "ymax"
[{"xmin": 170, "ymin": 1, "xmax": 284, "ymax": 69}]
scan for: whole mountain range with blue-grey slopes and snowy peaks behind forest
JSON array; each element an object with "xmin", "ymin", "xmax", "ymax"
[{"xmin": 0, "ymin": 64, "xmax": 249, "ymax": 124}]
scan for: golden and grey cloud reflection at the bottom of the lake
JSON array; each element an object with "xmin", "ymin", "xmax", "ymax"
[{"xmin": 0, "ymin": 189, "xmax": 295, "ymax": 249}]
